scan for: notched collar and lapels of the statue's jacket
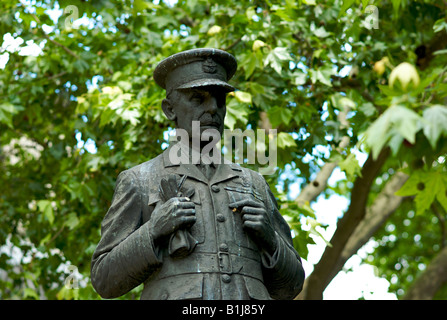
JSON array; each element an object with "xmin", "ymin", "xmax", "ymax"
[{"xmin": 163, "ymin": 144, "xmax": 243, "ymax": 185}]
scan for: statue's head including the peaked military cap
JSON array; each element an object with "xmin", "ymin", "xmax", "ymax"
[{"xmin": 154, "ymin": 49, "xmax": 237, "ymax": 137}]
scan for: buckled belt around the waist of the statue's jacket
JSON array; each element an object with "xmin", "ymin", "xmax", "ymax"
[{"xmin": 156, "ymin": 251, "xmax": 263, "ymax": 281}]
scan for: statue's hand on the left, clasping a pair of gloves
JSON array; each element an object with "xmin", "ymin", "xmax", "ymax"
[{"xmin": 149, "ymin": 197, "xmax": 196, "ymax": 240}]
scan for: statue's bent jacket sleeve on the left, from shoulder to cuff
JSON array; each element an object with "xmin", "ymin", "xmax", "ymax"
[{"xmin": 91, "ymin": 171, "xmax": 161, "ymax": 299}]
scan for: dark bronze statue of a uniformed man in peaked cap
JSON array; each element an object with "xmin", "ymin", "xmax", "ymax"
[{"xmin": 91, "ymin": 49, "xmax": 304, "ymax": 300}]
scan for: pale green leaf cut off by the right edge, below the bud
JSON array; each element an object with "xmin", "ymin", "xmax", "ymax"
[{"xmin": 422, "ymin": 105, "xmax": 447, "ymax": 149}]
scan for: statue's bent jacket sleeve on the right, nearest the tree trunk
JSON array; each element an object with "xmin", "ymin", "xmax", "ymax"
[{"xmin": 261, "ymin": 174, "xmax": 305, "ymax": 300}]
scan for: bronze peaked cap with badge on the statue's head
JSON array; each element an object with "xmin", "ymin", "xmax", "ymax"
[{"xmin": 154, "ymin": 48, "xmax": 237, "ymax": 93}]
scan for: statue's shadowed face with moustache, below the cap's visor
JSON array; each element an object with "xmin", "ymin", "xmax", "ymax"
[{"xmin": 165, "ymin": 87, "xmax": 227, "ymax": 137}]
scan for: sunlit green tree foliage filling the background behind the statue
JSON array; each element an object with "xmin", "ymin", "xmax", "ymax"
[{"xmin": 0, "ymin": 0, "xmax": 447, "ymax": 299}]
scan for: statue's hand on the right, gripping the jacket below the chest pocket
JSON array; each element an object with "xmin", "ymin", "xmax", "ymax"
[{"xmin": 229, "ymin": 198, "xmax": 277, "ymax": 254}]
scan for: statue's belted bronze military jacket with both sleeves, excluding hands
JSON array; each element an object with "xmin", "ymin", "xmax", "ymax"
[{"xmin": 91, "ymin": 148, "xmax": 304, "ymax": 300}]
